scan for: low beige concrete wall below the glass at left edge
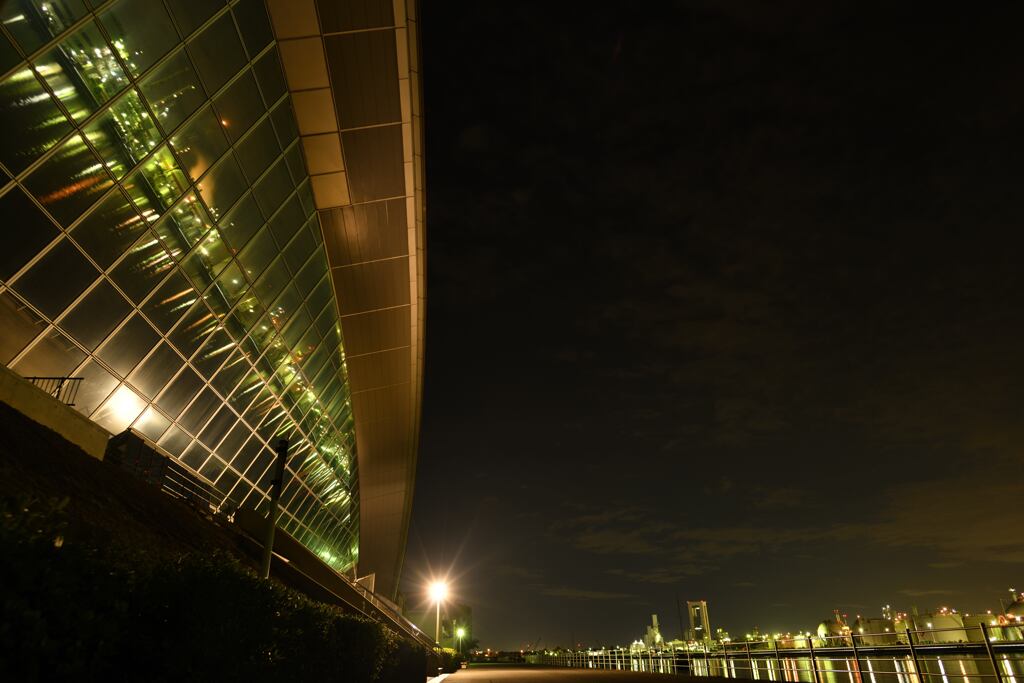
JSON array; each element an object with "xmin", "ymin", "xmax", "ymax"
[{"xmin": 0, "ymin": 366, "xmax": 111, "ymax": 460}]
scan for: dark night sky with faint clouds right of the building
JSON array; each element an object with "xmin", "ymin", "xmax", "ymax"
[{"xmin": 402, "ymin": 0, "xmax": 1024, "ymax": 648}]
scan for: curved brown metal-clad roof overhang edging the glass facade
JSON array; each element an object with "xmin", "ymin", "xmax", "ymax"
[{"xmin": 266, "ymin": 0, "xmax": 425, "ymax": 596}]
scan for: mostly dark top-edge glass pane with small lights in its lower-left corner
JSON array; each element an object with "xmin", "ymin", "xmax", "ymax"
[{"xmin": 99, "ymin": 0, "xmax": 178, "ymax": 76}]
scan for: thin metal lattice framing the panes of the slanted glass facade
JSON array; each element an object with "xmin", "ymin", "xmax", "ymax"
[{"xmin": 0, "ymin": 2, "xmax": 357, "ymax": 573}]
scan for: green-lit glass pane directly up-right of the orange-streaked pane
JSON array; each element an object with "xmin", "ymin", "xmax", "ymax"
[{"xmin": 85, "ymin": 90, "xmax": 161, "ymax": 178}]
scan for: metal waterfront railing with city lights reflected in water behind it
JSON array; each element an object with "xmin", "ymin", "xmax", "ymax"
[{"xmin": 540, "ymin": 624, "xmax": 1024, "ymax": 683}]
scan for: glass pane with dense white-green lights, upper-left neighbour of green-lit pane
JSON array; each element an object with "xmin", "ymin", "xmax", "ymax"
[{"xmin": 35, "ymin": 22, "xmax": 128, "ymax": 112}]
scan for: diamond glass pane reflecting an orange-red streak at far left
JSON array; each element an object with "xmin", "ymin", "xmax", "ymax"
[{"xmin": 25, "ymin": 135, "xmax": 114, "ymax": 225}]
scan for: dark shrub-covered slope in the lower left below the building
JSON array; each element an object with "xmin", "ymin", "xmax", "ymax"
[{"xmin": 0, "ymin": 403, "xmax": 425, "ymax": 681}]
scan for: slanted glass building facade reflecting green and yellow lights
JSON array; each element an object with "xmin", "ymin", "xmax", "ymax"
[{"xmin": 0, "ymin": 0, "xmax": 359, "ymax": 570}]
